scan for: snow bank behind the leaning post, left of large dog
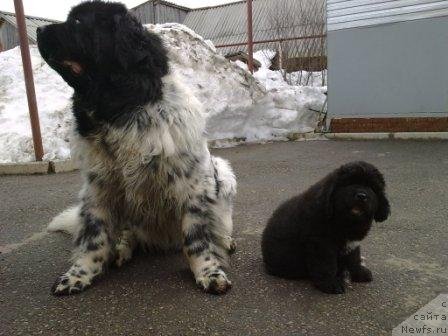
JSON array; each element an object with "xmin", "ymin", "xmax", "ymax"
[{"xmin": 0, "ymin": 46, "xmax": 72, "ymax": 162}]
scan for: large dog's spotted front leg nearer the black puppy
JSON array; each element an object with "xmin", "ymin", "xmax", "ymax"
[{"xmin": 182, "ymin": 200, "xmax": 232, "ymax": 294}]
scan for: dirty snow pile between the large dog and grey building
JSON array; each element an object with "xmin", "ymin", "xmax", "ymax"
[{"xmin": 148, "ymin": 23, "xmax": 325, "ymax": 141}]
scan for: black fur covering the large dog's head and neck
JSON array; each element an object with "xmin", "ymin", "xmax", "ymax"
[{"xmin": 37, "ymin": 1, "xmax": 168, "ymax": 136}]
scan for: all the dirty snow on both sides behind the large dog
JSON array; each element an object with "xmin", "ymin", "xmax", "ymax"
[{"xmin": 0, "ymin": 24, "xmax": 326, "ymax": 163}]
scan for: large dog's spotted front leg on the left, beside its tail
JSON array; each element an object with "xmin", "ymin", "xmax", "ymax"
[{"xmin": 52, "ymin": 209, "xmax": 111, "ymax": 295}]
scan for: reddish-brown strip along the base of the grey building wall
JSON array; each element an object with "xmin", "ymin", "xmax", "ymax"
[{"xmin": 330, "ymin": 117, "xmax": 448, "ymax": 133}]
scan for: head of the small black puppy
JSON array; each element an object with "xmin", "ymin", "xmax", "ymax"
[{"xmin": 321, "ymin": 162, "xmax": 390, "ymax": 238}]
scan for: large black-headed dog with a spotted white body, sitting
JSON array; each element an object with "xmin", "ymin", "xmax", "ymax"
[{"xmin": 37, "ymin": 1, "xmax": 236, "ymax": 295}]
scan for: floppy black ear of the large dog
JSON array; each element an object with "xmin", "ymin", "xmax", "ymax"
[{"xmin": 114, "ymin": 14, "xmax": 168, "ymax": 77}]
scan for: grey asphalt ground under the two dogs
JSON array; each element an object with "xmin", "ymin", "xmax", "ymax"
[{"xmin": 0, "ymin": 141, "xmax": 448, "ymax": 336}]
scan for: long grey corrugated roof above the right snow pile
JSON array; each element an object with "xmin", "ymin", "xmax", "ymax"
[{"xmin": 183, "ymin": 0, "xmax": 325, "ymax": 53}]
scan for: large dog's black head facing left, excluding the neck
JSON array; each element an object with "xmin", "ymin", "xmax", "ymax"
[{"xmin": 37, "ymin": 1, "xmax": 168, "ymax": 92}]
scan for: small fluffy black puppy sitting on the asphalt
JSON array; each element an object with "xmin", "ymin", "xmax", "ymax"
[{"xmin": 262, "ymin": 162, "xmax": 390, "ymax": 294}]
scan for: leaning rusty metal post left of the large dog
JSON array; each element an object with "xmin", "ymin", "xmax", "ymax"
[{"xmin": 14, "ymin": 0, "xmax": 44, "ymax": 161}]
